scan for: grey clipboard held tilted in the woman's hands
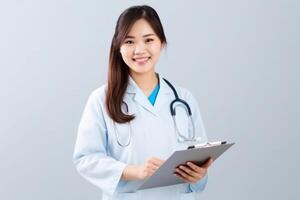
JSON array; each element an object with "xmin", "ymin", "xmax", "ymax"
[{"xmin": 136, "ymin": 143, "xmax": 235, "ymax": 190}]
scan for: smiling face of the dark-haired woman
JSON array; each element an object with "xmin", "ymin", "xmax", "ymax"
[{"xmin": 120, "ymin": 19, "xmax": 164, "ymax": 75}]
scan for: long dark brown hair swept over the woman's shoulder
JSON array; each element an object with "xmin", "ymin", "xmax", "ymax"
[{"xmin": 106, "ymin": 5, "xmax": 167, "ymax": 123}]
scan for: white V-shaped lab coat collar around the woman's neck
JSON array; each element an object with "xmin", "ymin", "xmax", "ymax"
[{"xmin": 126, "ymin": 73, "xmax": 173, "ymax": 116}]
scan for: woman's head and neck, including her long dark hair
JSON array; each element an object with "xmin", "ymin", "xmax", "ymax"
[{"xmin": 106, "ymin": 6, "xmax": 167, "ymax": 123}]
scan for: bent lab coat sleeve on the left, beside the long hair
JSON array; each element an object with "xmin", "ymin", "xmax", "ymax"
[{"xmin": 73, "ymin": 92, "xmax": 126, "ymax": 195}]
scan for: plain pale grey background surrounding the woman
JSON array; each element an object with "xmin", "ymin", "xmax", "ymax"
[{"xmin": 0, "ymin": 0, "xmax": 300, "ymax": 200}]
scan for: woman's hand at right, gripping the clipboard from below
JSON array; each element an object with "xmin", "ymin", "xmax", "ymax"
[{"xmin": 174, "ymin": 158, "xmax": 213, "ymax": 183}]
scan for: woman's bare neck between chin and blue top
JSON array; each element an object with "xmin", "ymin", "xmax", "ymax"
[{"xmin": 130, "ymin": 71, "xmax": 158, "ymax": 94}]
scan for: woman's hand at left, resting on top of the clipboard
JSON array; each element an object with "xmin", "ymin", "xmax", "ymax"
[{"xmin": 137, "ymin": 157, "xmax": 165, "ymax": 180}]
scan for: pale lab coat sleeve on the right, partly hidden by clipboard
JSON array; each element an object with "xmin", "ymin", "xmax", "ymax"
[{"xmin": 187, "ymin": 92, "xmax": 208, "ymax": 192}]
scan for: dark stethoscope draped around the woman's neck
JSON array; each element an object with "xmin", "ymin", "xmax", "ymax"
[{"xmin": 114, "ymin": 78, "xmax": 199, "ymax": 147}]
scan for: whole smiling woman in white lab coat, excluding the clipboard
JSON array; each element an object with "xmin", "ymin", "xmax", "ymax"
[{"xmin": 73, "ymin": 6, "xmax": 212, "ymax": 200}]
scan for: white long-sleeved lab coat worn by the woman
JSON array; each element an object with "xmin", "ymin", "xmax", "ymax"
[{"xmin": 73, "ymin": 76, "xmax": 207, "ymax": 200}]
